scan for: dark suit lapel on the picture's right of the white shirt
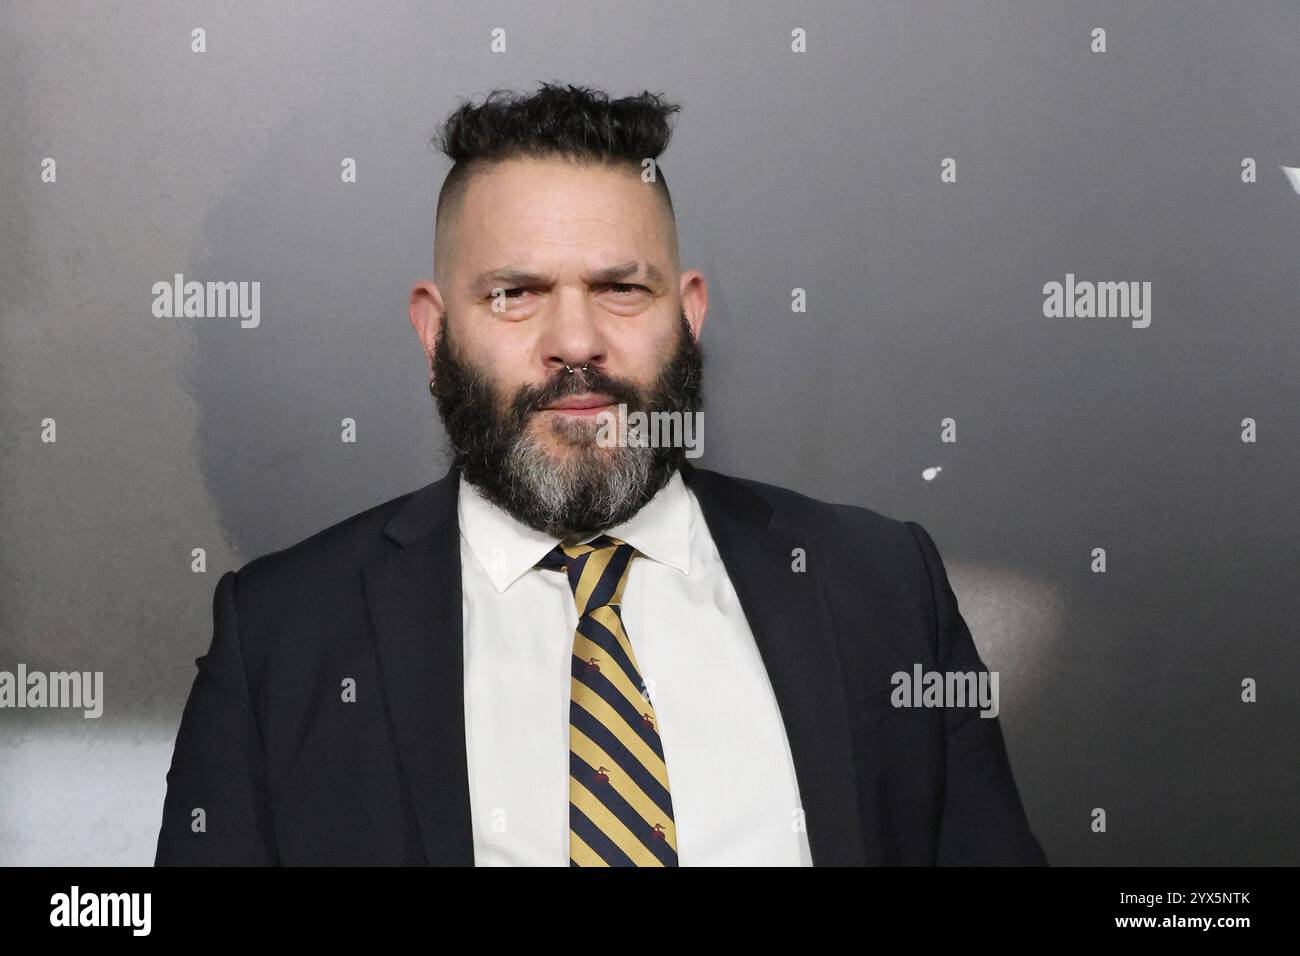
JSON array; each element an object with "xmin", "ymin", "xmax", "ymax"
[{"xmin": 681, "ymin": 462, "xmax": 866, "ymax": 866}]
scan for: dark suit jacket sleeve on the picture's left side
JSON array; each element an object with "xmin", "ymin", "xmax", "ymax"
[{"xmin": 153, "ymin": 571, "xmax": 278, "ymax": 866}]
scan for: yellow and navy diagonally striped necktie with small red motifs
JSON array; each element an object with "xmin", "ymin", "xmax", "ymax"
[{"xmin": 538, "ymin": 535, "xmax": 677, "ymax": 866}]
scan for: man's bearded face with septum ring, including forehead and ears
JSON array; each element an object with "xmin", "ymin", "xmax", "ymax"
[{"xmin": 411, "ymin": 159, "xmax": 707, "ymax": 537}]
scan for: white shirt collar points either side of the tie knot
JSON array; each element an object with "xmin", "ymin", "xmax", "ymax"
[{"xmin": 456, "ymin": 471, "xmax": 690, "ymax": 593}]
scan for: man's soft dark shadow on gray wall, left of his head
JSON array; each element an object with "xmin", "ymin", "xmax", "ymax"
[{"xmin": 185, "ymin": 100, "xmax": 446, "ymax": 561}]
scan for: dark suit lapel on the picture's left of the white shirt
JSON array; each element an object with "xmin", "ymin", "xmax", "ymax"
[{"xmin": 364, "ymin": 468, "xmax": 475, "ymax": 866}]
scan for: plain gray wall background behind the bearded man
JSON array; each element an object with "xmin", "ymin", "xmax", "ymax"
[{"xmin": 0, "ymin": 0, "xmax": 1300, "ymax": 864}]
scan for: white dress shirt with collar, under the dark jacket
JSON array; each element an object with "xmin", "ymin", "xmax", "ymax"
[{"xmin": 458, "ymin": 472, "xmax": 811, "ymax": 866}]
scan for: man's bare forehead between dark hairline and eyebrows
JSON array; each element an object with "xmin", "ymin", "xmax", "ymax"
[{"xmin": 456, "ymin": 159, "xmax": 670, "ymax": 269}]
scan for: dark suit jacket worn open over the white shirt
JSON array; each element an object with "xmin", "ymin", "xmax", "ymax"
[{"xmin": 155, "ymin": 463, "xmax": 1047, "ymax": 865}]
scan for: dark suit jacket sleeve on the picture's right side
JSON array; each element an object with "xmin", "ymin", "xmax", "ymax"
[{"xmin": 906, "ymin": 522, "xmax": 1048, "ymax": 866}]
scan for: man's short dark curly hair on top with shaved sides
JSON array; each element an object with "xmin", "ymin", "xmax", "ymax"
[{"xmin": 433, "ymin": 83, "xmax": 681, "ymax": 269}]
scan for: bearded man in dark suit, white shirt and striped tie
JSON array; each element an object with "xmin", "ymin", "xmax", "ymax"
[{"xmin": 156, "ymin": 85, "xmax": 1045, "ymax": 866}]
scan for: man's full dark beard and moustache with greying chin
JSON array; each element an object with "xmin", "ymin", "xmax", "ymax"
[{"xmin": 430, "ymin": 310, "xmax": 703, "ymax": 538}]
